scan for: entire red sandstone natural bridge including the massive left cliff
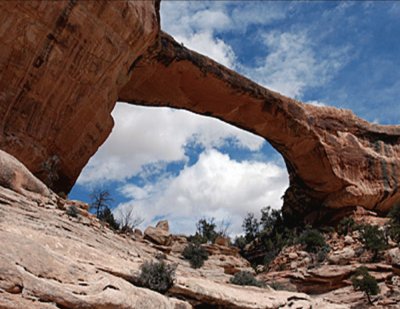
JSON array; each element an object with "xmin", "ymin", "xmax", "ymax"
[{"xmin": 0, "ymin": 0, "xmax": 400, "ymax": 220}]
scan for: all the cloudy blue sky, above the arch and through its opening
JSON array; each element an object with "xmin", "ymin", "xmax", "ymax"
[{"xmin": 70, "ymin": 1, "xmax": 400, "ymax": 234}]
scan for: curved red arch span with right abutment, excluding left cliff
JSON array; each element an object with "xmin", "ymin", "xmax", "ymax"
[{"xmin": 119, "ymin": 33, "xmax": 400, "ymax": 219}]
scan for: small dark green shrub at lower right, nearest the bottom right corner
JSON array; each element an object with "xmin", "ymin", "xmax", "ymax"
[{"xmin": 360, "ymin": 224, "xmax": 388, "ymax": 262}]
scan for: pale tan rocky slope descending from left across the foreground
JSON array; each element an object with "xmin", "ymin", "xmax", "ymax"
[{"xmin": 0, "ymin": 152, "xmax": 347, "ymax": 309}]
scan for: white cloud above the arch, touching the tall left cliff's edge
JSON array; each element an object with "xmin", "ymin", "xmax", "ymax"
[{"xmin": 161, "ymin": 1, "xmax": 286, "ymax": 68}]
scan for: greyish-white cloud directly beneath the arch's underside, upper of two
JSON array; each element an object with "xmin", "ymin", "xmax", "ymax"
[{"xmin": 78, "ymin": 103, "xmax": 264, "ymax": 185}]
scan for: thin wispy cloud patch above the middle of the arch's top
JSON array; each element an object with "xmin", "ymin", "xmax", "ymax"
[{"xmin": 242, "ymin": 31, "xmax": 347, "ymax": 98}]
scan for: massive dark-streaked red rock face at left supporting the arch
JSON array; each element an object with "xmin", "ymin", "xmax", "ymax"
[{"xmin": 0, "ymin": 0, "xmax": 159, "ymax": 191}]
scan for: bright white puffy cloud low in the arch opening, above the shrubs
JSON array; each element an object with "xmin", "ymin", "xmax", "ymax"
[{"xmin": 112, "ymin": 150, "xmax": 288, "ymax": 234}]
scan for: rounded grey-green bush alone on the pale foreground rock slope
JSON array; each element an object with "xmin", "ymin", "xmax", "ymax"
[{"xmin": 139, "ymin": 261, "xmax": 176, "ymax": 294}]
